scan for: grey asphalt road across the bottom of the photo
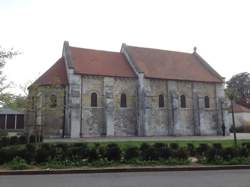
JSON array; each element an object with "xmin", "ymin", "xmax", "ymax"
[{"xmin": 0, "ymin": 170, "xmax": 250, "ymax": 187}]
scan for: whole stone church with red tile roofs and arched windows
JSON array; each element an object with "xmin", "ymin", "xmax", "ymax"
[{"xmin": 25, "ymin": 41, "xmax": 228, "ymax": 138}]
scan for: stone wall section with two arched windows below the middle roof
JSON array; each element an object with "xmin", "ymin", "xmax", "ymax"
[{"xmin": 81, "ymin": 76, "xmax": 137, "ymax": 137}]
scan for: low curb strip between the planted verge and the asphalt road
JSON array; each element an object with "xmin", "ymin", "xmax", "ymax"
[{"xmin": 0, "ymin": 165, "xmax": 250, "ymax": 176}]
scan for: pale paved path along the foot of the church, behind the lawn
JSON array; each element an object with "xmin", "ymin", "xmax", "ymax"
[{"xmin": 44, "ymin": 133, "xmax": 250, "ymax": 142}]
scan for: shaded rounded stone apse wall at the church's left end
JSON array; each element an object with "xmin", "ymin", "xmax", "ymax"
[{"xmin": 26, "ymin": 86, "xmax": 65, "ymax": 137}]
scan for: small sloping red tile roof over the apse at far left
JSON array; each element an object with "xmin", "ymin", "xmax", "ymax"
[{"xmin": 33, "ymin": 57, "xmax": 68, "ymax": 85}]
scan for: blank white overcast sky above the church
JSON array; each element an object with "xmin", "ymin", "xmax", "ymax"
[{"xmin": 0, "ymin": 0, "xmax": 250, "ymax": 92}]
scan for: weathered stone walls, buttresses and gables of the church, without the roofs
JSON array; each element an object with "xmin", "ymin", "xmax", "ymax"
[{"xmin": 26, "ymin": 42, "xmax": 228, "ymax": 138}]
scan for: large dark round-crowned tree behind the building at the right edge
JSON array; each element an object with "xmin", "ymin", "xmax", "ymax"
[{"xmin": 227, "ymin": 72, "xmax": 250, "ymax": 107}]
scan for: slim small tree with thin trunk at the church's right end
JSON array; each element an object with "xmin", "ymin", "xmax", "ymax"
[{"xmin": 225, "ymin": 88, "xmax": 240, "ymax": 146}]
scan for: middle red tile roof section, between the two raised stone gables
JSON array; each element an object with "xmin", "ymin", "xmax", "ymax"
[{"xmin": 70, "ymin": 47, "xmax": 135, "ymax": 77}]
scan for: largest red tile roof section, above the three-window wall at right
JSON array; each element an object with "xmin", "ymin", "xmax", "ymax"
[{"xmin": 127, "ymin": 46, "xmax": 223, "ymax": 83}]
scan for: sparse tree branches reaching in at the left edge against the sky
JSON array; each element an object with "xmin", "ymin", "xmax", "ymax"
[{"xmin": 0, "ymin": 46, "xmax": 19, "ymax": 105}]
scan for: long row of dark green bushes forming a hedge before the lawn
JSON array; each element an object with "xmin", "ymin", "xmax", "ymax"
[{"xmin": 0, "ymin": 140, "xmax": 250, "ymax": 164}]
